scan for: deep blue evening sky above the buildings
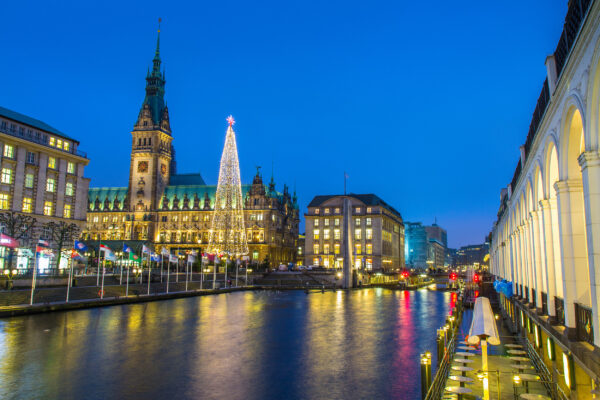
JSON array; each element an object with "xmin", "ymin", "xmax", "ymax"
[{"xmin": 0, "ymin": 0, "xmax": 567, "ymax": 247}]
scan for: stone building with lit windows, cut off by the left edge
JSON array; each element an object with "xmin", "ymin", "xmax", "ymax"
[{"xmin": 0, "ymin": 107, "xmax": 90, "ymax": 271}]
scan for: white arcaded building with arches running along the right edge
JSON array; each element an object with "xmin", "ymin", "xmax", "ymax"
[{"xmin": 490, "ymin": 0, "xmax": 600, "ymax": 399}]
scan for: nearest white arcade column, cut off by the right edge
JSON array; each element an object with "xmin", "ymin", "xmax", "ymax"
[{"xmin": 578, "ymin": 151, "xmax": 600, "ymax": 346}]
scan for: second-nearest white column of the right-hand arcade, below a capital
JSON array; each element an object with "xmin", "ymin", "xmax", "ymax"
[{"xmin": 554, "ymin": 179, "xmax": 590, "ymax": 328}]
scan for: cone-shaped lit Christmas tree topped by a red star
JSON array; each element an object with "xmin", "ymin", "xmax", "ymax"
[{"xmin": 208, "ymin": 115, "xmax": 248, "ymax": 257}]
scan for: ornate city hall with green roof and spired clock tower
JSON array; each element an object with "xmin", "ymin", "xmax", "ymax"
[{"xmin": 84, "ymin": 32, "xmax": 299, "ymax": 265}]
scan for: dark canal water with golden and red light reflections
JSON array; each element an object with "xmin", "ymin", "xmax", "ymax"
[{"xmin": 0, "ymin": 289, "xmax": 452, "ymax": 400}]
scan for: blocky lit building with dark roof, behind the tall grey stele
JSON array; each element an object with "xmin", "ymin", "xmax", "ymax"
[{"xmin": 304, "ymin": 194, "xmax": 404, "ymax": 272}]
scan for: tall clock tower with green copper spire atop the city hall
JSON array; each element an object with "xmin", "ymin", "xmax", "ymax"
[{"xmin": 126, "ymin": 29, "xmax": 173, "ymax": 214}]
